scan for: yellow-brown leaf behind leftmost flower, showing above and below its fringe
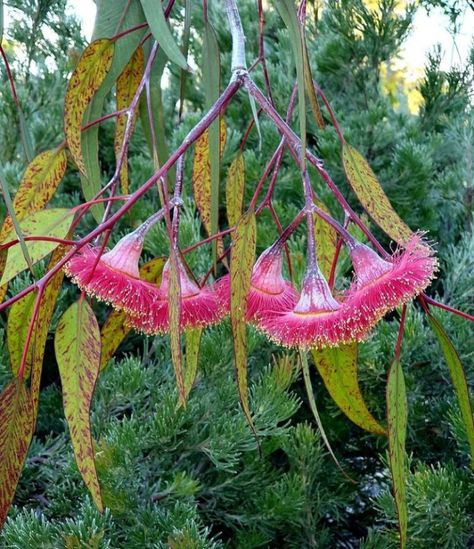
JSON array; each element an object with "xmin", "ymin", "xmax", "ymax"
[{"xmin": 100, "ymin": 257, "xmax": 166, "ymax": 370}]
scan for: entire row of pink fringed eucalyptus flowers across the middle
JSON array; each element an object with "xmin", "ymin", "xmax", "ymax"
[{"xmin": 65, "ymin": 229, "xmax": 437, "ymax": 349}]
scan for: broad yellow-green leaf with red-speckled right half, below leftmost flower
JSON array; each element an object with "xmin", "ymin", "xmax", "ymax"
[{"xmin": 54, "ymin": 299, "xmax": 103, "ymax": 511}]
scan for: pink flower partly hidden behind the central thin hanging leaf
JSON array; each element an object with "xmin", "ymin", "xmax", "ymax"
[{"xmin": 216, "ymin": 247, "xmax": 298, "ymax": 321}]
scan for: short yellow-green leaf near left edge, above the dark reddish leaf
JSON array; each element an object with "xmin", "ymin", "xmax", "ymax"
[{"xmin": 7, "ymin": 292, "xmax": 36, "ymax": 379}]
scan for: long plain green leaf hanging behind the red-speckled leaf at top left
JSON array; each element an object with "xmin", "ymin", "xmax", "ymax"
[{"xmin": 81, "ymin": 0, "xmax": 147, "ymax": 222}]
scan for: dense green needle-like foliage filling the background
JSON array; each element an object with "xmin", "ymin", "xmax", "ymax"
[{"xmin": 0, "ymin": 0, "xmax": 474, "ymax": 549}]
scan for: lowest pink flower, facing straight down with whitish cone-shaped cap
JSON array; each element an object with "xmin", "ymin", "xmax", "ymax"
[{"xmin": 257, "ymin": 268, "xmax": 358, "ymax": 349}]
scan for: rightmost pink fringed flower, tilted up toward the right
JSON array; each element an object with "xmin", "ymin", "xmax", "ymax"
[{"xmin": 345, "ymin": 234, "xmax": 438, "ymax": 326}]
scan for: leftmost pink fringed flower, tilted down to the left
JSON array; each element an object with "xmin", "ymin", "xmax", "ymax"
[{"xmin": 64, "ymin": 233, "xmax": 158, "ymax": 316}]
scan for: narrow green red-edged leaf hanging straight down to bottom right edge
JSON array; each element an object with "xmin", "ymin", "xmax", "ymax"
[{"xmin": 387, "ymin": 359, "xmax": 408, "ymax": 549}]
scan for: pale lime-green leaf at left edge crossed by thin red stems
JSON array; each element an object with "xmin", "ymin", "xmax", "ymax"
[{"xmin": 0, "ymin": 208, "xmax": 74, "ymax": 286}]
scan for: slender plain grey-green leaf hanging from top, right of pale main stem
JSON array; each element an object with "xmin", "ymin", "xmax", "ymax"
[{"xmin": 275, "ymin": 0, "xmax": 306, "ymax": 163}]
